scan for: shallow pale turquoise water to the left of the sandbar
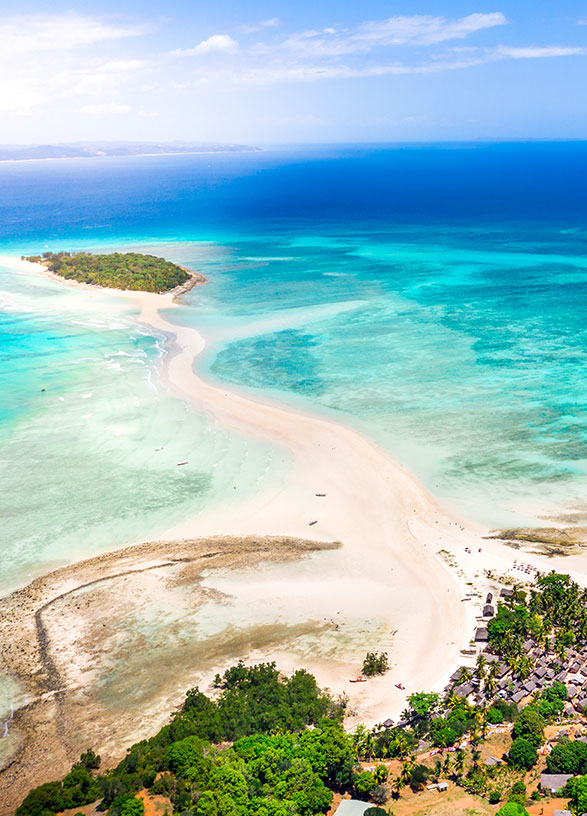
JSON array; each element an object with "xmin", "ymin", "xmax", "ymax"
[{"xmin": 0, "ymin": 267, "xmax": 281, "ymax": 591}]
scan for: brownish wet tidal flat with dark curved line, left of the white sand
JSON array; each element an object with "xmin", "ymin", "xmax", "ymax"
[{"xmin": 0, "ymin": 536, "xmax": 336, "ymax": 816}]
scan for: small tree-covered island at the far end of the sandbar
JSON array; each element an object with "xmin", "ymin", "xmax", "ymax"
[{"xmin": 23, "ymin": 252, "xmax": 205, "ymax": 294}]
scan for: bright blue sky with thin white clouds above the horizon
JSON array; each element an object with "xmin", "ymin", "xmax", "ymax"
[{"xmin": 0, "ymin": 0, "xmax": 587, "ymax": 145}]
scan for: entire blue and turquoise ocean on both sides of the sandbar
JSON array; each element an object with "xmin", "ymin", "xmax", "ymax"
[{"xmin": 0, "ymin": 142, "xmax": 587, "ymax": 592}]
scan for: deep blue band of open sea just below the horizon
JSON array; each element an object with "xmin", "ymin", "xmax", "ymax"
[{"xmin": 0, "ymin": 142, "xmax": 587, "ymax": 244}]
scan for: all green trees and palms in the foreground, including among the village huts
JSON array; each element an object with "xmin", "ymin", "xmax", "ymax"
[{"xmin": 17, "ymin": 573, "xmax": 587, "ymax": 816}]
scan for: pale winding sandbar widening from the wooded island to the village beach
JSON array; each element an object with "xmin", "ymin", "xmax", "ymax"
[{"xmin": 5, "ymin": 253, "xmax": 584, "ymax": 808}]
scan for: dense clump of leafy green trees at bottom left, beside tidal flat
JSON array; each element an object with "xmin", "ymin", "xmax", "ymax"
[{"xmin": 16, "ymin": 663, "xmax": 354, "ymax": 816}]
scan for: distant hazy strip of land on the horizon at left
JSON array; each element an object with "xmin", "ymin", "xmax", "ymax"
[{"xmin": 0, "ymin": 142, "xmax": 261, "ymax": 161}]
